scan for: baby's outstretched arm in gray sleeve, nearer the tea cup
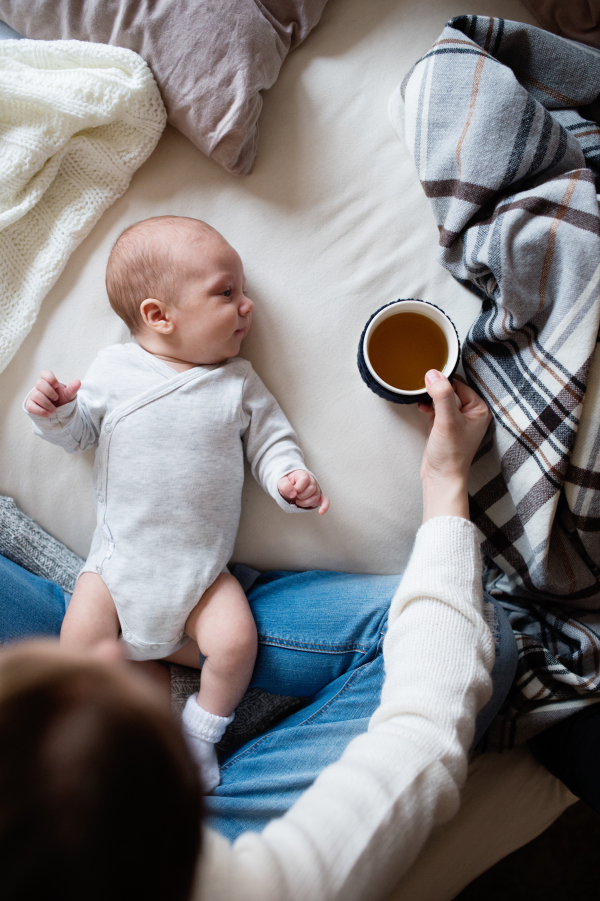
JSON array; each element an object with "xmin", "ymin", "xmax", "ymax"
[{"xmin": 242, "ymin": 369, "xmax": 329, "ymax": 513}]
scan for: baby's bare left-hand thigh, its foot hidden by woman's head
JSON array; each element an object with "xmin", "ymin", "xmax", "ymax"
[{"xmin": 60, "ymin": 573, "xmax": 120, "ymax": 651}]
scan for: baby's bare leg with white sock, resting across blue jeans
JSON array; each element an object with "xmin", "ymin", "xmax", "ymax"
[{"xmin": 177, "ymin": 573, "xmax": 257, "ymax": 792}]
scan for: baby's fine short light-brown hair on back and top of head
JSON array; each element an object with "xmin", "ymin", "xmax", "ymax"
[{"xmin": 106, "ymin": 216, "xmax": 225, "ymax": 335}]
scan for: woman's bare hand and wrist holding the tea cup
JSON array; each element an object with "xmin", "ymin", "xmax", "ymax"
[{"xmin": 419, "ymin": 369, "xmax": 491, "ymax": 522}]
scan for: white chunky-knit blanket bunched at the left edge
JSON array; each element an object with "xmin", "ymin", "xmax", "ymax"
[{"xmin": 0, "ymin": 40, "xmax": 166, "ymax": 372}]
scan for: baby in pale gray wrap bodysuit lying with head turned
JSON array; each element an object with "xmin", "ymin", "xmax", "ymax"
[{"xmin": 25, "ymin": 216, "xmax": 329, "ymax": 792}]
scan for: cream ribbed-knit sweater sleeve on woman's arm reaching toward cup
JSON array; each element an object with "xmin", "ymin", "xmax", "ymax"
[{"xmin": 194, "ymin": 516, "xmax": 494, "ymax": 901}]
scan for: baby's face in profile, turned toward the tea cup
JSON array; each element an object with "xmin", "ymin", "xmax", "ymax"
[{"xmin": 170, "ymin": 237, "xmax": 254, "ymax": 365}]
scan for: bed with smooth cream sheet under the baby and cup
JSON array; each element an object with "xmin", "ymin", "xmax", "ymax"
[{"xmin": 0, "ymin": 0, "xmax": 576, "ymax": 901}]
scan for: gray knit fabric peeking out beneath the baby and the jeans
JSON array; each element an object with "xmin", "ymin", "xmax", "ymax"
[{"xmin": 0, "ymin": 496, "xmax": 304, "ymax": 754}]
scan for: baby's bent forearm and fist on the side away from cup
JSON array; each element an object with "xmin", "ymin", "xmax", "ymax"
[{"xmin": 23, "ymin": 369, "xmax": 105, "ymax": 453}]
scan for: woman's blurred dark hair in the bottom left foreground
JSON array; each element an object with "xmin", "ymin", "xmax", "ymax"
[{"xmin": 0, "ymin": 644, "xmax": 202, "ymax": 901}]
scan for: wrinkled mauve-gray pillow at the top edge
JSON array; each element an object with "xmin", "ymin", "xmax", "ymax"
[{"xmin": 0, "ymin": 0, "xmax": 327, "ymax": 175}]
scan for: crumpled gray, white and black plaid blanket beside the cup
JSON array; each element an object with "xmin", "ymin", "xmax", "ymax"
[{"xmin": 390, "ymin": 16, "xmax": 600, "ymax": 748}]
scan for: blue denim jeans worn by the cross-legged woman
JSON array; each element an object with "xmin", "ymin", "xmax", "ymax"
[{"xmin": 0, "ymin": 556, "xmax": 517, "ymax": 840}]
